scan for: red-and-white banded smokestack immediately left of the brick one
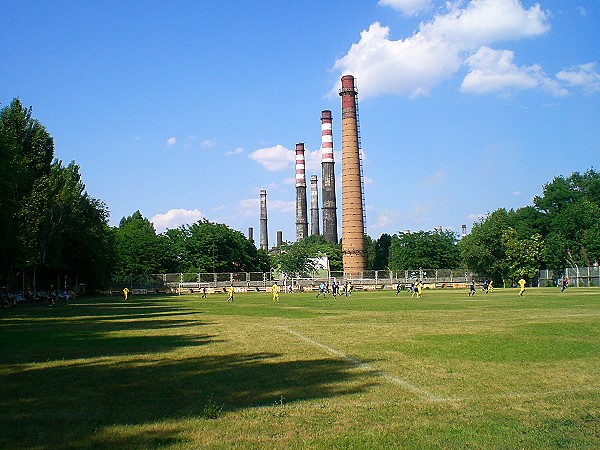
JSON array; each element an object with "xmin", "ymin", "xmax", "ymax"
[{"xmin": 321, "ymin": 110, "xmax": 338, "ymax": 244}]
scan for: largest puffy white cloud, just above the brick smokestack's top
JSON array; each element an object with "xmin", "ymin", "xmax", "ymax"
[{"xmin": 334, "ymin": 0, "xmax": 550, "ymax": 99}]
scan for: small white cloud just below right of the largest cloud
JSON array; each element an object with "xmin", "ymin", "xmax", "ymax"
[{"xmin": 461, "ymin": 46, "xmax": 567, "ymax": 96}]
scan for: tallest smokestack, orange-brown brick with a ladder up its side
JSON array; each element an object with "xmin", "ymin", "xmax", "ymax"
[{"xmin": 340, "ymin": 75, "xmax": 366, "ymax": 276}]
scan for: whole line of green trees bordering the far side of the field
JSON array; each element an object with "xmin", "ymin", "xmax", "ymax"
[{"xmin": 0, "ymin": 99, "xmax": 600, "ymax": 289}]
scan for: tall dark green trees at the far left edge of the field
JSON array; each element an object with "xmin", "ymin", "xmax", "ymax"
[{"xmin": 0, "ymin": 99, "xmax": 112, "ymax": 288}]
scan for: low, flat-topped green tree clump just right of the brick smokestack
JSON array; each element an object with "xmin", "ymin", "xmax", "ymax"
[{"xmin": 389, "ymin": 230, "xmax": 461, "ymax": 270}]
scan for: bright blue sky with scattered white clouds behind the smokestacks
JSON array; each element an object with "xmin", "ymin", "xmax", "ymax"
[{"xmin": 0, "ymin": 0, "xmax": 600, "ymax": 244}]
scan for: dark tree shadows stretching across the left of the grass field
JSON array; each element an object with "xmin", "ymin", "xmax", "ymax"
[{"xmin": 0, "ymin": 303, "xmax": 371, "ymax": 448}]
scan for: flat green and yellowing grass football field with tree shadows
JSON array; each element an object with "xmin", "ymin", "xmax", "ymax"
[{"xmin": 0, "ymin": 288, "xmax": 600, "ymax": 449}]
